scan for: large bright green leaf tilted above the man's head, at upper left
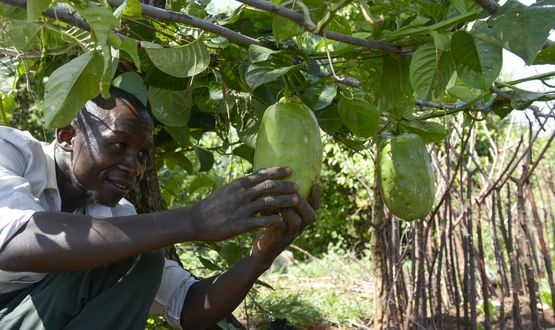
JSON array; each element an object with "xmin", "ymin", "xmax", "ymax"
[{"xmin": 43, "ymin": 52, "xmax": 104, "ymax": 128}]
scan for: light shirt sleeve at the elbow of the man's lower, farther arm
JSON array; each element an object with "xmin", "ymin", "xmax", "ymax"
[{"xmin": 150, "ymin": 259, "xmax": 198, "ymax": 329}]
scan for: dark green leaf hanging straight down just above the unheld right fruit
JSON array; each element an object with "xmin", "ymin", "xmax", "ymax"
[{"xmin": 378, "ymin": 56, "xmax": 414, "ymax": 119}]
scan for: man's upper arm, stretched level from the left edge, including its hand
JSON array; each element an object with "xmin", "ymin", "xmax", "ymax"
[{"xmin": 0, "ymin": 168, "xmax": 298, "ymax": 272}]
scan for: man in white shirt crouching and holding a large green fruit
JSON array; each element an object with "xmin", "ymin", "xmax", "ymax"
[{"xmin": 0, "ymin": 88, "xmax": 319, "ymax": 329}]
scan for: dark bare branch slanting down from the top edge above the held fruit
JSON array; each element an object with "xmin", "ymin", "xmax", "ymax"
[{"xmin": 236, "ymin": 0, "xmax": 403, "ymax": 54}]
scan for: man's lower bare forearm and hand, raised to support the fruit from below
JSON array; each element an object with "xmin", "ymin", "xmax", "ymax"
[{"xmin": 181, "ymin": 185, "xmax": 320, "ymax": 329}]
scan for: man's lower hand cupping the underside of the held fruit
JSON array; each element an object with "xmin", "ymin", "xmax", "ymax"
[{"xmin": 251, "ymin": 184, "xmax": 320, "ymax": 267}]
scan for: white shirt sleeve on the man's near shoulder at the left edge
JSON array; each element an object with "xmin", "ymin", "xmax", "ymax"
[{"xmin": 0, "ymin": 139, "xmax": 43, "ymax": 248}]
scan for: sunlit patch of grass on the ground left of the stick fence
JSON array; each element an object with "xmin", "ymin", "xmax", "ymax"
[{"xmin": 236, "ymin": 253, "xmax": 373, "ymax": 329}]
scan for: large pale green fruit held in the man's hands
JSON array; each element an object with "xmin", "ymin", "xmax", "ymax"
[{"xmin": 254, "ymin": 98, "xmax": 322, "ymax": 198}]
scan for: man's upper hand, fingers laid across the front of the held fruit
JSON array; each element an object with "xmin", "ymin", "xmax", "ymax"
[{"xmin": 193, "ymin": 167, "xmax": 300, "ymax": 241}]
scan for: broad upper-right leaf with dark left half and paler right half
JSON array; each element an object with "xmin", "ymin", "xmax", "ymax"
[{"xmin": 451, "ymin": 31, "xmax": 503, "ymax": 90}]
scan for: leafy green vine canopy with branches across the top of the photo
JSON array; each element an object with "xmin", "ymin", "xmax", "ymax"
[{"xmin": 0, "ymin": 0, "xmax": 555, "ymax": 171}]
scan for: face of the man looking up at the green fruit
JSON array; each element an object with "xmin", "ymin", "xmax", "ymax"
[{"xmin": 71, "ymin": 99, "xmax": 154, "ymax": 206}]
